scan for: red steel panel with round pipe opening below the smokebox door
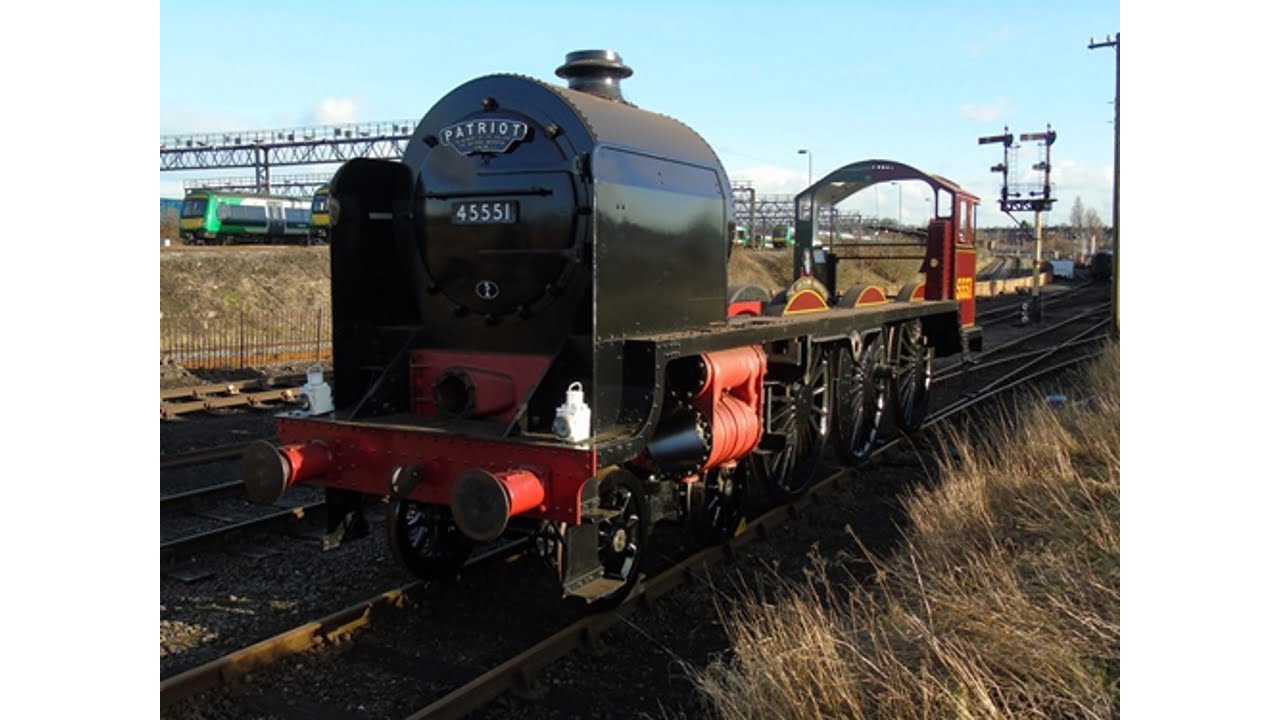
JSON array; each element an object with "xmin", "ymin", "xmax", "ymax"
[{"xmin": 410, "ymin": 350, "xmax": 552, "ymax": 423}]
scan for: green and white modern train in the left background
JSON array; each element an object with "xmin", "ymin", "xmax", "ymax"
[{"xmin": 178, "ymin": 190, "xmax": 311, "ymax": 245}]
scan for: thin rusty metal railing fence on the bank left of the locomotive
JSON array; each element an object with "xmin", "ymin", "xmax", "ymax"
[{"xmin": 160, "ymin": 309, "xmax": 333, "ymax": 369}]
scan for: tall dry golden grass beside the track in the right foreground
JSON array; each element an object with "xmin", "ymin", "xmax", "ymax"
[{"xmin": 694, "ymin": 347, "xmax": 1120, "ymax": 719}]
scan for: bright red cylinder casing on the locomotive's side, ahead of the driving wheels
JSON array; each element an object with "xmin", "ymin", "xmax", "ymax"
[{"xmin": 694, "ymin": 345, "xmax": 767, "ymax": 470}]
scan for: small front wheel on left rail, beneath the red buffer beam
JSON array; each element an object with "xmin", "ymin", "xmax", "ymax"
[{"xmin": 387, "ymin": 500, "xmax": 472, "ymax": 580}]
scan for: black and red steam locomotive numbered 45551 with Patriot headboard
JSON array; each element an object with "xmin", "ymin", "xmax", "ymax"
[{"xmin": 244, "ymin": 51, "xmax": 982, "ymax": 606}]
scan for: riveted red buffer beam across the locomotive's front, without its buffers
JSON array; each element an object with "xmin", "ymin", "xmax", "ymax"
[{"xmin": 276, "ymin": 418, "xmax": 596, "ymax": 524}]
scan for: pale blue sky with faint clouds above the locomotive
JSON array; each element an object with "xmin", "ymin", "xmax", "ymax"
[{"xmin": 160, "ymin": 0, "xmax": 1120, "ymax": 224}]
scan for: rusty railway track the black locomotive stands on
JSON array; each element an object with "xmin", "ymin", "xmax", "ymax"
[{"xmin": 161, "ymin": 293, "xmax": 1108, "ymax": 719}]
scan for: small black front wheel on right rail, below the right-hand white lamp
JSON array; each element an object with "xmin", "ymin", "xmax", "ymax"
[{"xmin": 591, "ymin": 468, "xmax": 649, "ymax": 610}]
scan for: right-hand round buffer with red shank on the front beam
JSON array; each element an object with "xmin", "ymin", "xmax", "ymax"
[{"xmin": 449, "ymin": 468, "xmax": 547, "ymax": 542}]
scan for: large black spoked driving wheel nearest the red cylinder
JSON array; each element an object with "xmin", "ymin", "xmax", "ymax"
[{"xmin": 755, "ymin": 343, "xmax": 833, "ymax": 502}]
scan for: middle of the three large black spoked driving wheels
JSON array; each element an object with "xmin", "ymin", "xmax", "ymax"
[{"xmin": 835, "ymin": 334, "xmax": 884, "ymax": 464}]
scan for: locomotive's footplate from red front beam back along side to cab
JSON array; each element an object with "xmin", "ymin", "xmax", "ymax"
[{"xmin": 269, "ymin": 294, "xmax": 959, "ymax": 517}]
